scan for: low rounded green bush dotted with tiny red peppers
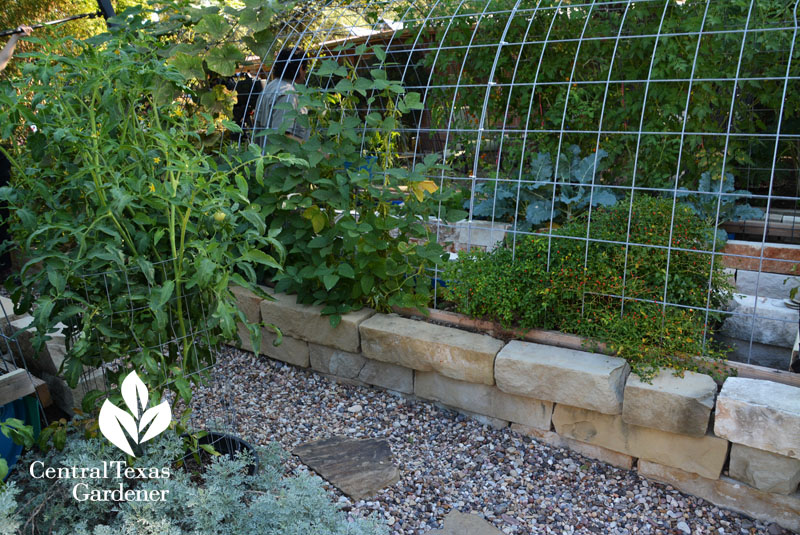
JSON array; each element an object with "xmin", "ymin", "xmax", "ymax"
[{"xmin": 445, "ymin": 195, "xmax": 731, "ymax": 378}]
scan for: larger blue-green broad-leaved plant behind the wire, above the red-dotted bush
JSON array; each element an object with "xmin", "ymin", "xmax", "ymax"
[{"xmin": 472, "ymin": 145, "xmax": 617, "ymax": 230}]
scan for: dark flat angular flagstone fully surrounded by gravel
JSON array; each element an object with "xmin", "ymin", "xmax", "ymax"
[{"xmin": 292, "ymin": 437, "xmax": 400, "ymax": 500}]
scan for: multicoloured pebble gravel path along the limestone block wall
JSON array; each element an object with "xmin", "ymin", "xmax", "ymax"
[{"xmin": 195, "ymin": 348, "xmax": 789, "ymax": 535}]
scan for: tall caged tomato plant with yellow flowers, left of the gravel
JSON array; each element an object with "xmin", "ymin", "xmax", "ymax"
[{"xmin": 0, "ymin": 30, "xmax": 284, "ymax": 416}]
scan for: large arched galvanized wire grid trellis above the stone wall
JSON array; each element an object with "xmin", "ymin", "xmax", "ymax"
[{"xmin": 242, "ymin": 0, "xmax": 800, "ymax": 369}]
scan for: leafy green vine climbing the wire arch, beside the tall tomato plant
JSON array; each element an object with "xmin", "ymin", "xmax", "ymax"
[{"xmin": 249, "ymin": 46, "xmax": 460, "ymax": 324}]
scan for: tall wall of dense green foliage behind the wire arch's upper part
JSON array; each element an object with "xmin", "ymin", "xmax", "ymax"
[{"xmin": 404, "ymin": 0, "xmax": 800, "ymax": 211}]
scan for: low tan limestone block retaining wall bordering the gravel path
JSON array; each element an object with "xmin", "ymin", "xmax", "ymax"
[{"xmin": 237, "ymin": 288, "xmax": 800, "ymax": 532}]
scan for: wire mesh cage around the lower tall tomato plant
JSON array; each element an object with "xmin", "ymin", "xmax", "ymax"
[{"xmin": 56, "ymin": 260, "xmax": 237, "ymax": 432}]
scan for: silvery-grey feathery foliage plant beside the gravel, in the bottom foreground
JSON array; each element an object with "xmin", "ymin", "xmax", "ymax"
[{"xmin": 0, "ymin": 434, "xmax": 388, "ymax": 535}]
